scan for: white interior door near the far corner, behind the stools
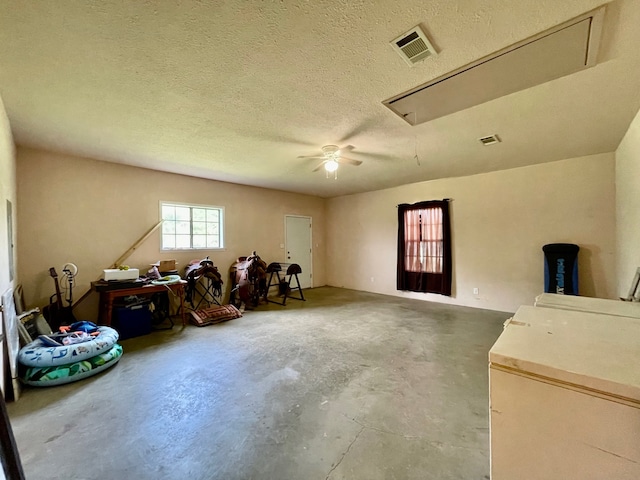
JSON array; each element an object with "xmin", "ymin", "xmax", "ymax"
[{"xmin": 284, "ymin": 215, "xmax": 313, "ymax": 288}]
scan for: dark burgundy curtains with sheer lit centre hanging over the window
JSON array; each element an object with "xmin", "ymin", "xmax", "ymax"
[{"xmin": 397, "ymin": 200, "xmax": 452, "ymax": 296}]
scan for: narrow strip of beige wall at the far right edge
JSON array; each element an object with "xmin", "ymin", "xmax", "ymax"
[{"xmin": 615, "ymin": 107, "xmax": 640, "ymax": 297}]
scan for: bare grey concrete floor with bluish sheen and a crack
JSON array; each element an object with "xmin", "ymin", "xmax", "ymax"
[{"xmin": 8, "ymin": 287, "xmax": 509, "ymax": 480}]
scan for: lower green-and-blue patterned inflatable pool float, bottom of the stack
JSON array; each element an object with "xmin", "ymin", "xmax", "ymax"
[{"xmin": 20, "ymin": 343, "xmax": 122, "ymax": 387}]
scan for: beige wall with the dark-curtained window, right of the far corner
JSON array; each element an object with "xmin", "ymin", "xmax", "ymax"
[{"xmin": 327, "ymin": 154, "xmax": 616, "ymax": 311}]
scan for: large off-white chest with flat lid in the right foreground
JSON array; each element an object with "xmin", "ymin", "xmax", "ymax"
[{"xmin": 489, "ymin": 306, "xmax": 640, "ymax": 480}]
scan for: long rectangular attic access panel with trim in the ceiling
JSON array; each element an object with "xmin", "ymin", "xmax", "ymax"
[{"xmin": 382, "ymin": 6, "xmax": 605, "ymax": 125}]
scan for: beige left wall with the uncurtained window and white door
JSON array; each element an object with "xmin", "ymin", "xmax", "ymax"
[{"xmin": 17, "ymin": 147, "xmax": 326, "ymax": 320}]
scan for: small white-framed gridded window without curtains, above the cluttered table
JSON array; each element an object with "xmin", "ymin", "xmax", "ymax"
[{"xmin": 160, "ymin": 202, "xmax": 224, "ymax": 250}]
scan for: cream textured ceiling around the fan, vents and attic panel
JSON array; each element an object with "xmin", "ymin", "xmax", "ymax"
[{"xmin": 0, "ymin": 0, "xmax": 640, "ymax": 197}]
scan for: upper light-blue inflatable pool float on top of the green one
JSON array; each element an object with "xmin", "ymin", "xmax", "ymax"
[{"xmin": 18, "ymin": 327, "xmax": 118, "ymax": 367}]
